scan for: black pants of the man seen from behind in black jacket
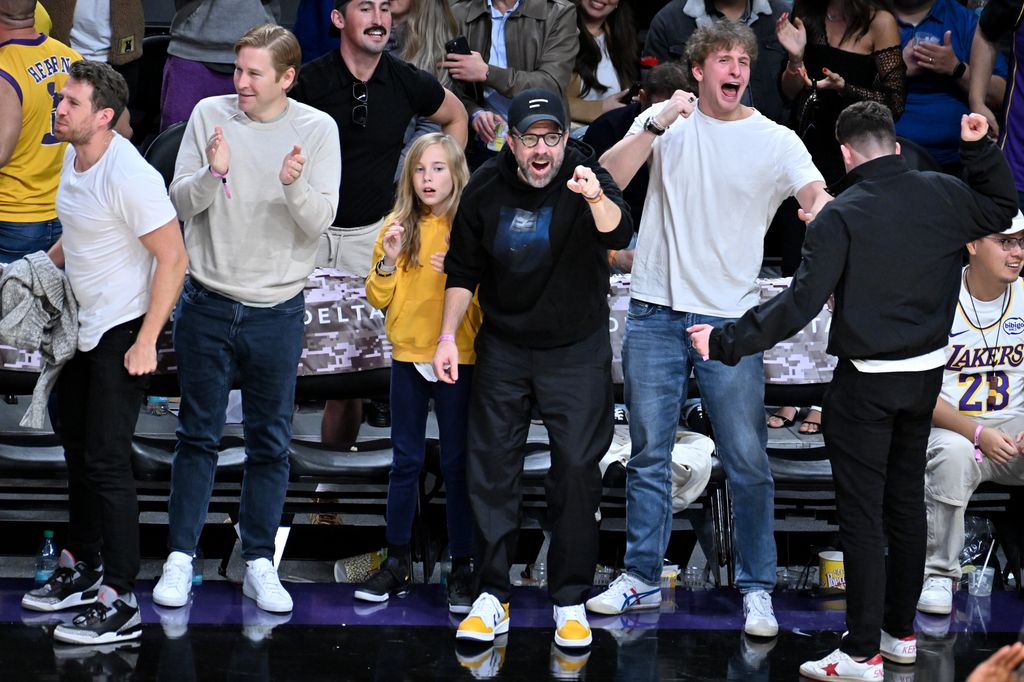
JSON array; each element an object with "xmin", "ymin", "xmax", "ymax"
[{"xmin": 822, "ymin": 360, "xmax": 942, "ymax": 657}]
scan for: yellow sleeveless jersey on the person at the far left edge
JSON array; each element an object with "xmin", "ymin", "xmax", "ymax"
[{"xmin": 0, "ymin": 34, "xmax": 82, "ymax": 222}]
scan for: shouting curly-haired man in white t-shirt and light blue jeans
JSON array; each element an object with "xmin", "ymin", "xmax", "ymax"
[{"xmin": 587, "ymin": 22, "xmax": 828, "ymax": 637}]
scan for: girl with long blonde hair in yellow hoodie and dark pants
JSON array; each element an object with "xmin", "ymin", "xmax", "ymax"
[{"xmin": 355, "ymin": 133, "xmax": 481, "ymax": 613}]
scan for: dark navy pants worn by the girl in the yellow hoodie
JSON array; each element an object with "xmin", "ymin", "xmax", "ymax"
[{"xmin": 387, "ymin": 360, "xmax": 473, "ymax": 558}]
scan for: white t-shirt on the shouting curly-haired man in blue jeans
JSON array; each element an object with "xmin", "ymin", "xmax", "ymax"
[{"xmin": 628, "ymin": 103, "xmax": 823, "ymax": 317}]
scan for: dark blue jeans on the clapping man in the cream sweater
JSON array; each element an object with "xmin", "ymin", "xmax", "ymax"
[{"xmin": 168, "ymin": 279, "xmax": 304, "ymax": 560}]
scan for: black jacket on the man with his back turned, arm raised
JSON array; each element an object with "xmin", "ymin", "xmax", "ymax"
[{"xmin": 710, "ymin": 135, "xmax": 1017, "ymax": 365}]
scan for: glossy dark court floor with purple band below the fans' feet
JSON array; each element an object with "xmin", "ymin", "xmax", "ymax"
[{"xmin": 0, "ymin": 580, "xmax": 1024, "ymax": 682}]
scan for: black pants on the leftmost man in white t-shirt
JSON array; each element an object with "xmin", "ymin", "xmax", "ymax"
[{"xmin": 57, "ymin": 317, "xmax": 147, "ymax": 593}]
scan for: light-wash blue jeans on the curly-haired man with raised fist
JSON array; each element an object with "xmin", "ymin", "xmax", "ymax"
[{"xmin": 623, "ymin": 299, "xmax": 777, "ymax": 593}]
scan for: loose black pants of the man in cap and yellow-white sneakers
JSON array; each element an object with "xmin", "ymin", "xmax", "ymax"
[{"xmin": 467, "ymin": 327, "xmax": 613, "ymax": 606}]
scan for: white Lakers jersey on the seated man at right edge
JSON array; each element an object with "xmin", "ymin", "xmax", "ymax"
[{"xmin": 942, "ymin": 266, "xmax": 1024, "ymax": 419}]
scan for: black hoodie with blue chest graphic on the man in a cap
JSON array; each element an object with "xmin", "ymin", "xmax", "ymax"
[{"xmin": 444, "ymin": 140, "xmax": 633, "ymax": 348}]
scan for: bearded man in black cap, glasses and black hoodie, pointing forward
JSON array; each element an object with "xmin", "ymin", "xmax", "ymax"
[{"xmin": 433, "ymin": 88, "xmax": 633, "ymax": 647}]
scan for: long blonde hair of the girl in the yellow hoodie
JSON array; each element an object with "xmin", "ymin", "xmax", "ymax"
[{"xmin": 390, "ymin": 133, "xmax": 469, "ymax": 270}]
